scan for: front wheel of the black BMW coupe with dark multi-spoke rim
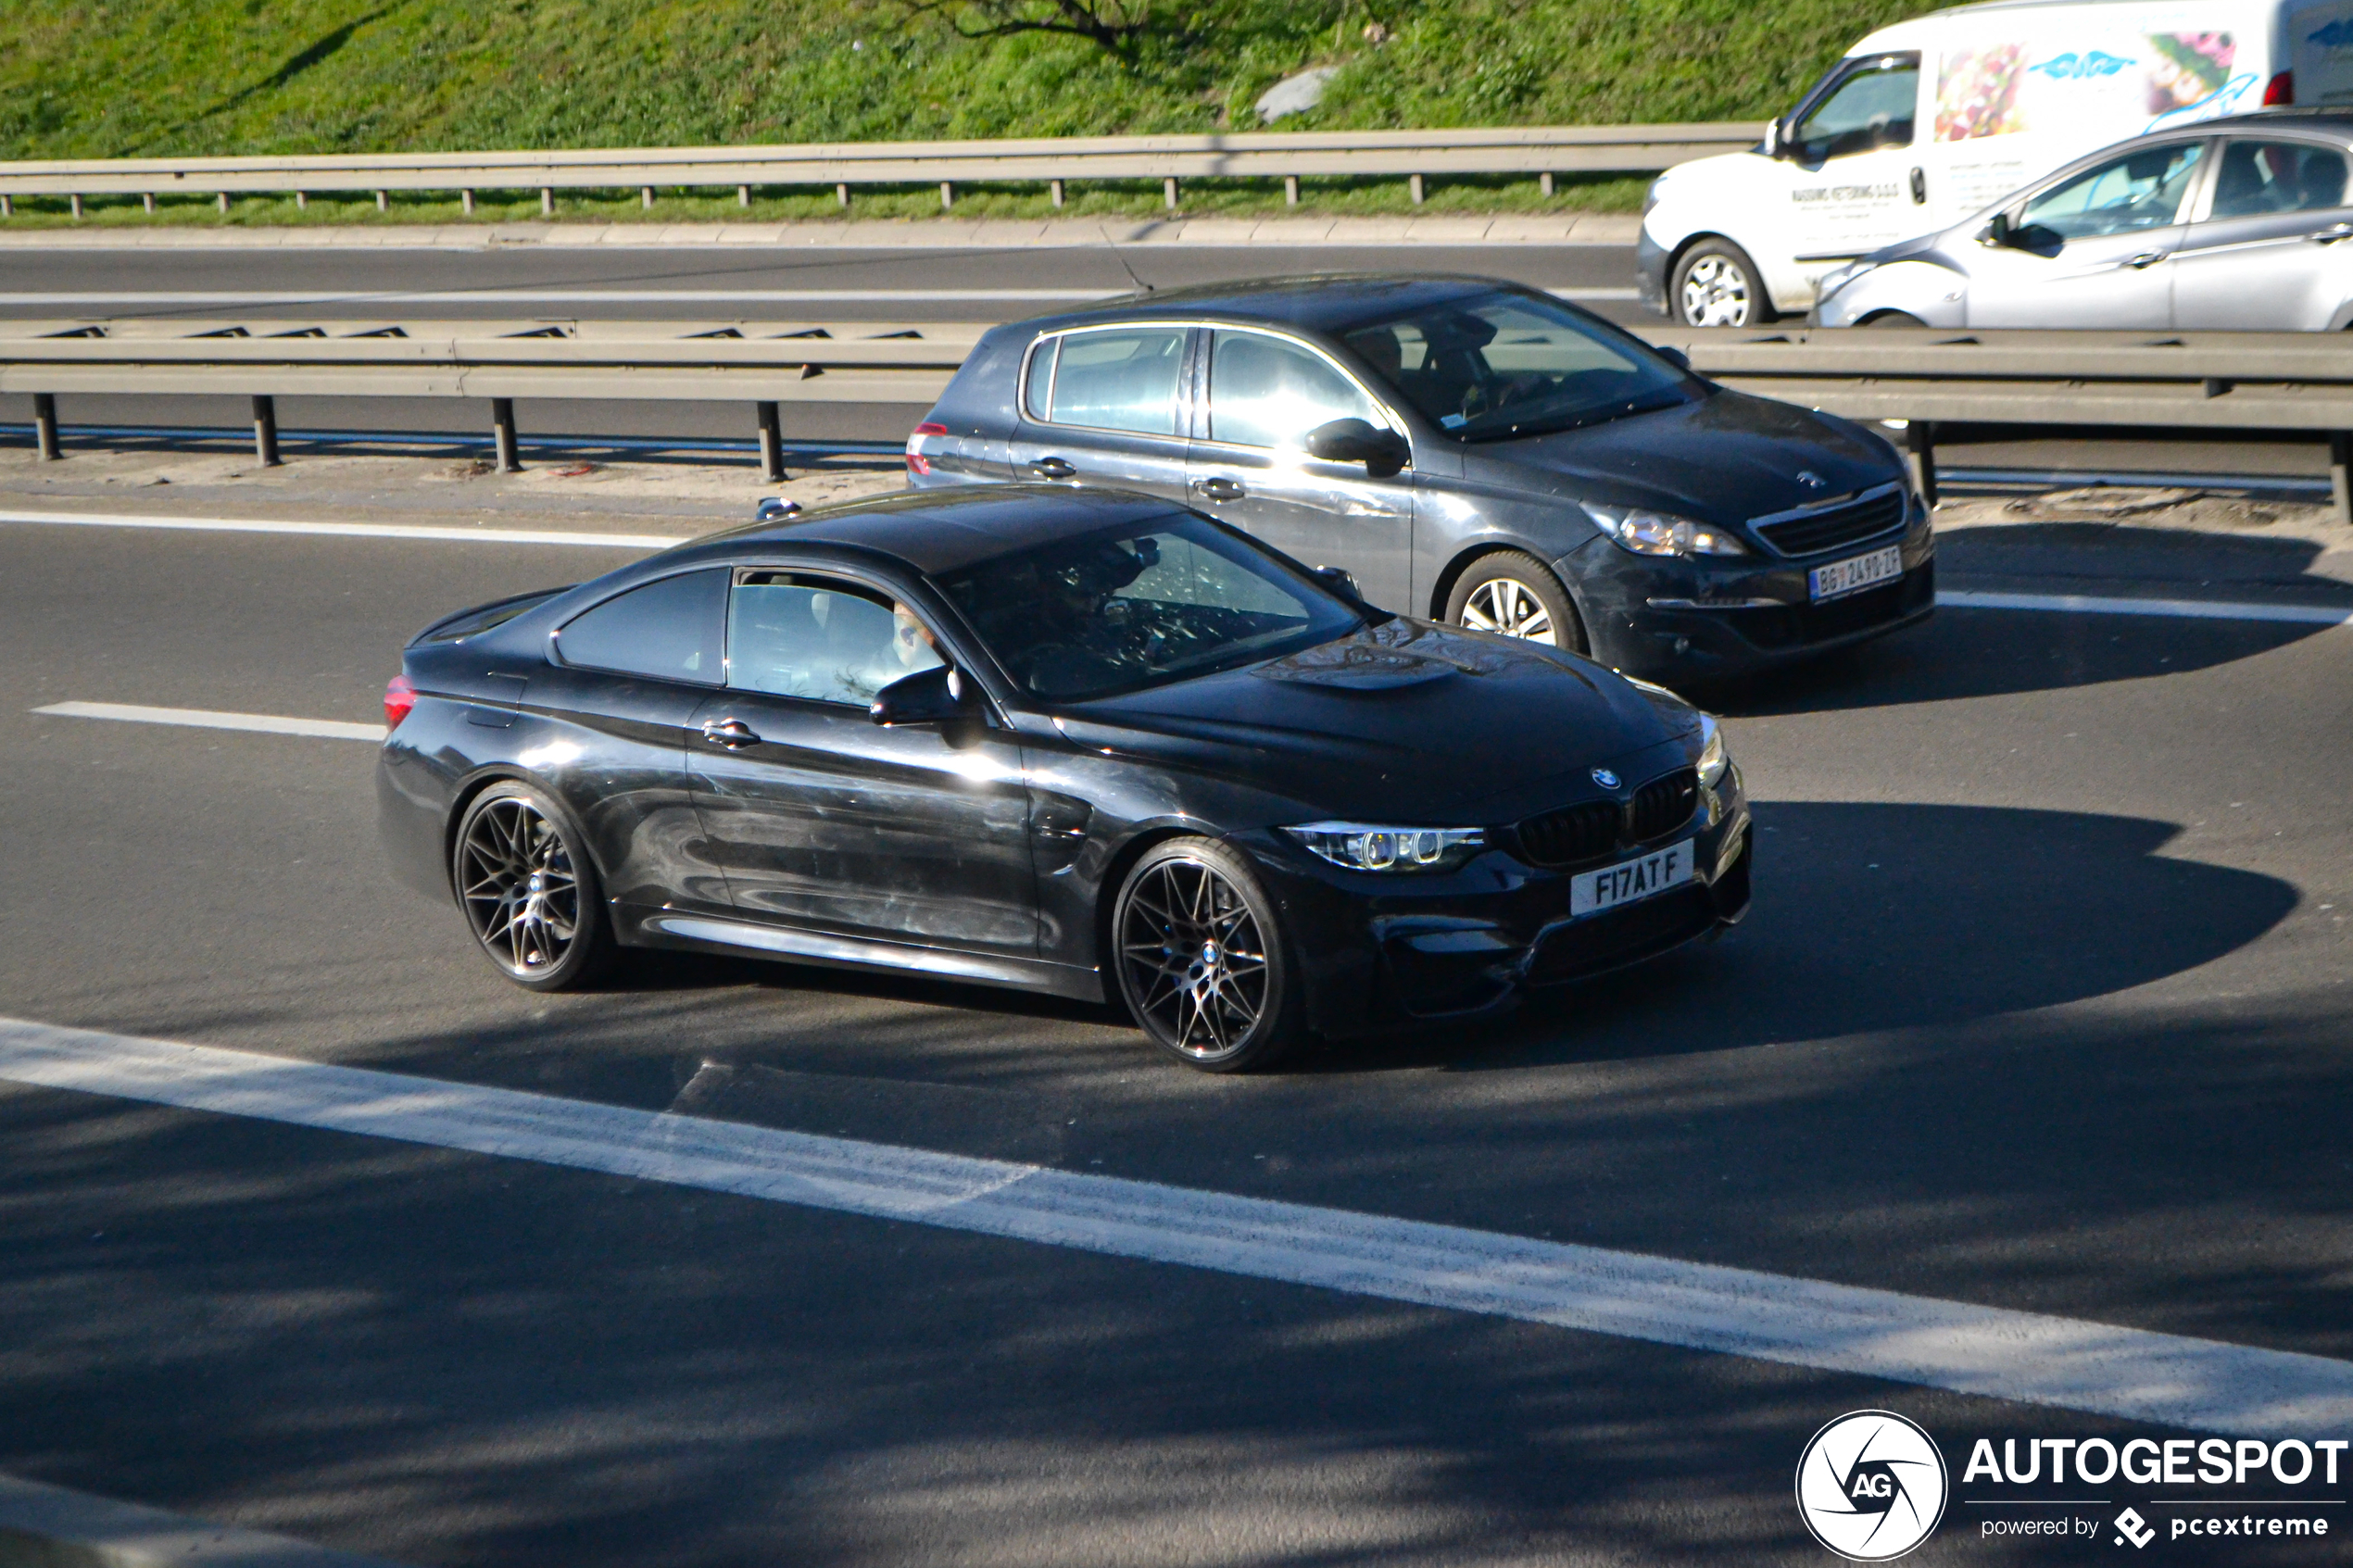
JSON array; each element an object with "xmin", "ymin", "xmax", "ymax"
[{"xmin": 1111, "ymin": 837, "xmax": 1306, "ymax": 1072}]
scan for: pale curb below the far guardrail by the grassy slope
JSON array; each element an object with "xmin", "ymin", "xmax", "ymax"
[{"xmin": 0, "ymin": 211, "xmax": 1642, "ymax": 249}]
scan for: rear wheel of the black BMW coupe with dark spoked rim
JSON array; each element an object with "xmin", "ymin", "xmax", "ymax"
[{"xmin": 449, "ymin": 781, "xmax": 614, "ymax": 992}]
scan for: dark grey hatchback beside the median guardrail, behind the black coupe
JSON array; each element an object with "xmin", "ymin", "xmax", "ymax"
[{"xmin": 906, "ymin": 275, "xmax": 1936, "ymax": 680}]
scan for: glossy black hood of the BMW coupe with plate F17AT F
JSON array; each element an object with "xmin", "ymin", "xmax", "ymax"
[{"xmin": 1056, "ymin": 616, "xmax": 1699, "ymax": 822}]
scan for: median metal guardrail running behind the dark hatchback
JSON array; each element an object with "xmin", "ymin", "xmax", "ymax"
[{"xmin": 13, "ymin": 320, "xmax": 2353, "ymax": 521}]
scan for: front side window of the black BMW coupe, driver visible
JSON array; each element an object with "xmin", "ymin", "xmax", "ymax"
[{"xmin": 727, "ymin": 571, "xmax": 946, "ymax": 708}]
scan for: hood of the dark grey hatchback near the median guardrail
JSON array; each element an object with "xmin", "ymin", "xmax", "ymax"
[{"xmin": 1464, "ymin": 388, "xmax": 1904, "ymax": 524}]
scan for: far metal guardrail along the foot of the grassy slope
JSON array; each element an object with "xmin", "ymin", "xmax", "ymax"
[{"xmin": 0, "ymin": 122, "xmax": 1765, "ymax": 217}]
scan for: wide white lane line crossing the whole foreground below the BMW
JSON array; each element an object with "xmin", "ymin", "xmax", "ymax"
[{"xmin": 0, "ymin": 1018, "xmax": 2353, "ymax": 1436}]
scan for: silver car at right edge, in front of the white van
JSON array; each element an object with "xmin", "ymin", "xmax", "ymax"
[{"xmin": 1814, "ymin": 108, "xmax": 2353, "ymax": 332}]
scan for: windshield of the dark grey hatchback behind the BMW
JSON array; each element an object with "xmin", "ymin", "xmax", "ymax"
[{"xmin": 1346, "ymin": 289, "xmax": 1694, "ymax": 442}]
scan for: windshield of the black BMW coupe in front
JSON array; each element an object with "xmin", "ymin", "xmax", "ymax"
[{"xmin": 938, "ymin": 515, "xmax": 1363, "ymax": 700}]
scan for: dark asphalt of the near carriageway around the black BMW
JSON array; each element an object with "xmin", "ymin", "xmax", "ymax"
[{"xmin": 0, "ymin": 505, "xmax": 2353, "ymax": 1568}]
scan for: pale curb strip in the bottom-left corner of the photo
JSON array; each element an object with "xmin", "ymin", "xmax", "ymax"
[{"xmin": 0, "ymin": 1476, "xmax": 397, "ymax": 1568}]
